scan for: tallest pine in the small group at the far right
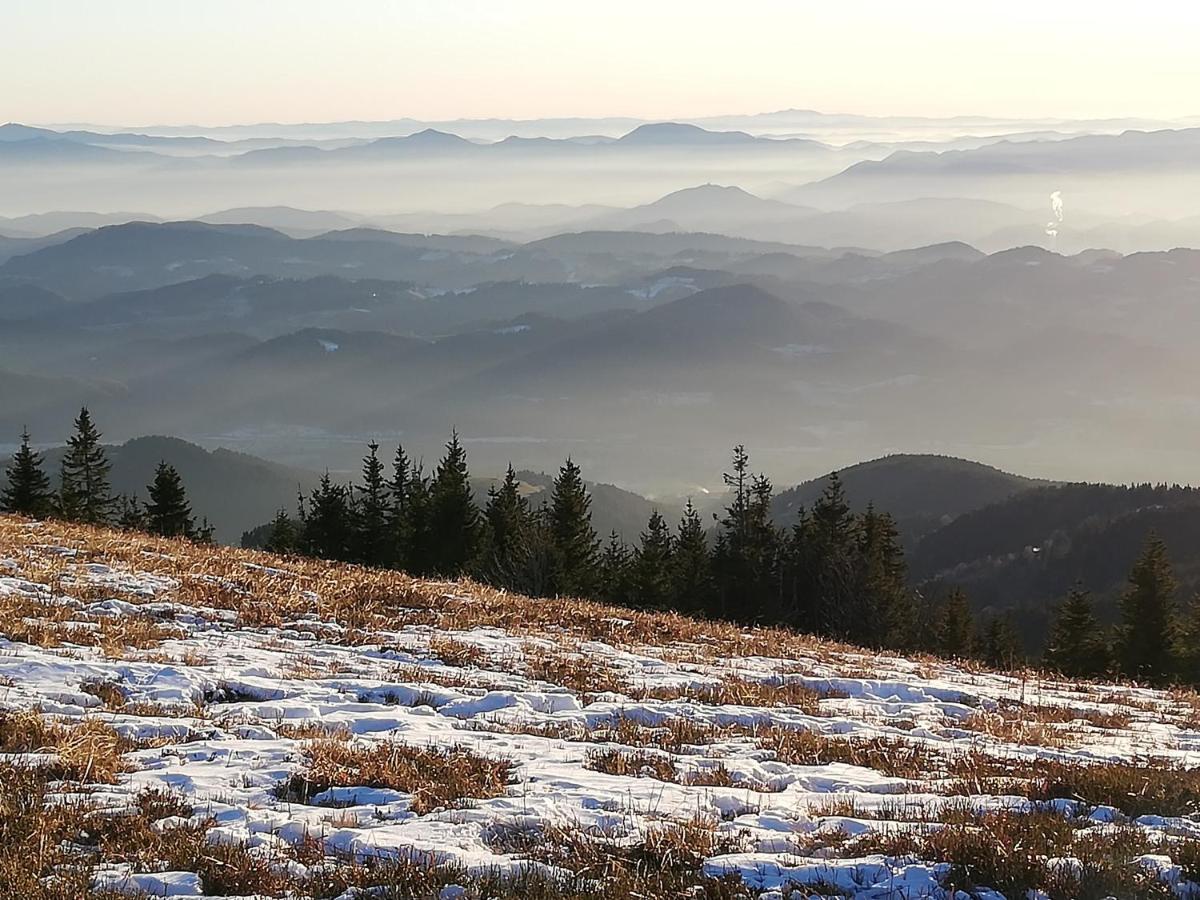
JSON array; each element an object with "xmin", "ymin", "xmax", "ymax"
[{"xmin": 1117, "ymin": 534, "xmax": 1176, "ymax": 684}]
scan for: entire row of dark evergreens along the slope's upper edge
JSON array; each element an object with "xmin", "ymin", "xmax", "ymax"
[{"xmin": 0, "ymin": 408, "xmax": 1180, "ymax": 683}]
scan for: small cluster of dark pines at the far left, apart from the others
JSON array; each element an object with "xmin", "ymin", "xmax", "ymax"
[{"xmin": 0, "ymin": 407, "xmax": 212, "ymax": 544}]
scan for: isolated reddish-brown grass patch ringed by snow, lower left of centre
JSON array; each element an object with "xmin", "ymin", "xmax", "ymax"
[{"xmin": 277, "ymin": 737, "xmax": 514, "ymax": 816}]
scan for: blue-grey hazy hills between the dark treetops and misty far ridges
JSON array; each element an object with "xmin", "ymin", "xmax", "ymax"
[{"xmin": 0, "ymin": 219, "xmax": 1200, "ymax": 493}]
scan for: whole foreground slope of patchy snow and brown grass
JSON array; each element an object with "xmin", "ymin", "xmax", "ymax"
[{"xmin": 0, "ymin": 517, "xmax": 1200, "ymax": 900}]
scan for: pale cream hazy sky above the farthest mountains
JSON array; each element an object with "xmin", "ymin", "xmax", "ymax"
[{"xmin": 9, "ymin": 0, "xmax": 1200, "ymax": 125}]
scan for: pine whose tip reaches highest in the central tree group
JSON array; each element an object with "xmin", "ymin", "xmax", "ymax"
[{"xmin": 428, "ymin": 431, "xmax": 481, "ymax": 576}]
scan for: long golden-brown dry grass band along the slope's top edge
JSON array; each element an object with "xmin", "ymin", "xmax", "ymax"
[{"xmin": 0, "ymin": 516, "xmax": 852, "ymax": 676}]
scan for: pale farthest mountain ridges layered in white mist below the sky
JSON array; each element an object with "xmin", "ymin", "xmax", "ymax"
[{"xmin": 9, "ymin": 110, "xmax": 1200, "ymax": 232}]
